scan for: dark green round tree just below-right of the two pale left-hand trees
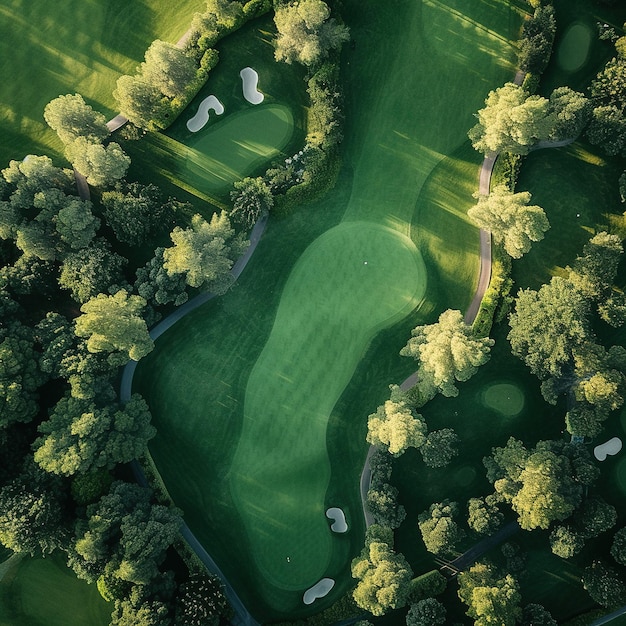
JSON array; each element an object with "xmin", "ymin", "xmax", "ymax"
[{"xmin": 102, "ymin": 183, "xmax": 172, "ymax": 246}]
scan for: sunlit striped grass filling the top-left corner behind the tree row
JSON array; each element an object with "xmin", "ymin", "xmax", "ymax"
[{"xmin": 0, "ymin": 0, "xmax": 202, "ymax": 167}]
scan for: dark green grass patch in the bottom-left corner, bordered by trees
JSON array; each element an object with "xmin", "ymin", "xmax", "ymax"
[{"xmin": 0, "ymin": 554, "xmax": 113, "ymax": 626}]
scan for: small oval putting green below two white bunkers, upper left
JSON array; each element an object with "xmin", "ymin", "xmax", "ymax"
[{"xmin": 185, "ymin": 104, "xmax": 294, "ymax": 192}]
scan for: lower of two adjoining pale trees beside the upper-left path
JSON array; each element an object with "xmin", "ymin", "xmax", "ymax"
[{"xmin": 66, "ymin": 137, "xmax": 130, "ymax": 187}]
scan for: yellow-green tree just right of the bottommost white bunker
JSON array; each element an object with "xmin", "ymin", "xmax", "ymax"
[{"xmin": 352, "ymin": 525, "xmax": 413, "ymax": 615}]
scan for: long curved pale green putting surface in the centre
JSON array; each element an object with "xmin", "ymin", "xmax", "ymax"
[{"xmin": 229, "ymin": 222, "xmax": 426, "ymax": 592}]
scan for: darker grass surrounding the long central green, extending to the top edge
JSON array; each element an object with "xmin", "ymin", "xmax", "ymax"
[{"xmin": 137, "ymin": 2, "xmax": 519, "ymax": 614}]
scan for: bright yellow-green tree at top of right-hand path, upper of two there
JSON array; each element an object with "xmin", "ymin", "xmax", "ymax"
[{"xmin": 468, "ymin": 83, "xmax": 556, "ymax": 154}]
